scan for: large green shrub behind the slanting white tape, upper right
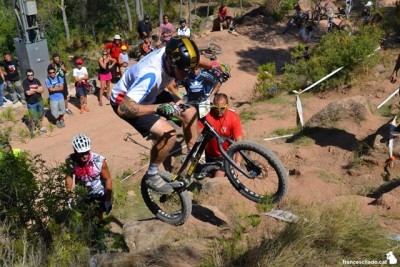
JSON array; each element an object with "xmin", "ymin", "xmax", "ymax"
[{"xmin": 282, "ymin": 26, "xmax": 382, "ymax": 91}]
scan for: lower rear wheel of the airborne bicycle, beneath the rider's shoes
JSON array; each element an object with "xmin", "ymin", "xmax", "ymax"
[{"xmin": 141, "ymin": 170, "xmax": 192, "ymax": 225}]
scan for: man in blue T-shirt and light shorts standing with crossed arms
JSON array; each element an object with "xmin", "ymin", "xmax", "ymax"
[{"xmin": 46, "ymin": 67, "xmax": 65, "ymax": 128}]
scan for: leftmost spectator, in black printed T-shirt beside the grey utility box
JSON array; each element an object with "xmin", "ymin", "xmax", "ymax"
[{"xmin": 0, "ymin": 52, "xmax": 26, "ymax": 105}]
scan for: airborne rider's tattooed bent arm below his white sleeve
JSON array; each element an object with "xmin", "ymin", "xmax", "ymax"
[{"xmin": 117, "ymin": 96, "xmax": 157, "ymax": 118}]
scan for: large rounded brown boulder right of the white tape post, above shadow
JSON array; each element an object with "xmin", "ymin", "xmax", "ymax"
[{"xmin": 305, "ymin": 96, "xmax": 372, "ymax": 129}]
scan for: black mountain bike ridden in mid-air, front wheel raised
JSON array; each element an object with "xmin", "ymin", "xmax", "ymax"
[{"xmin": 141, "ymin": 92, "xmax": 289, "ymax": 225}]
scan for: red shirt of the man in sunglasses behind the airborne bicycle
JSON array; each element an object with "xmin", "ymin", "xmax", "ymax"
[{"xmin": 200, "ymin": 109, "xmax": 243, "ymax": 157}]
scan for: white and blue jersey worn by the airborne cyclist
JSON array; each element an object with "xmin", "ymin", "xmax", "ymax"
[{"xmin": 111, "ymin": 47, "xmax": 174, "ymax": 105}]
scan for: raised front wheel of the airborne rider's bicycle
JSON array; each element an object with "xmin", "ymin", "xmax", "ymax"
[{"xmin": 224, "ymin": 141, "xmax": 289, "ymax": 203}]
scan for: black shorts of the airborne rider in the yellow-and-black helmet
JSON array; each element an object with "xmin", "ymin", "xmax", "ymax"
[{"xmin": 110, "ymin": 91, "xmax": 178, "ymax": 137}]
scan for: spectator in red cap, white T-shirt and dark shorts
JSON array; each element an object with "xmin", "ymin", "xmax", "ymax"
[{"xmin": 72, "ymin": 58, "xmax": 89, "ymax": 114}]
